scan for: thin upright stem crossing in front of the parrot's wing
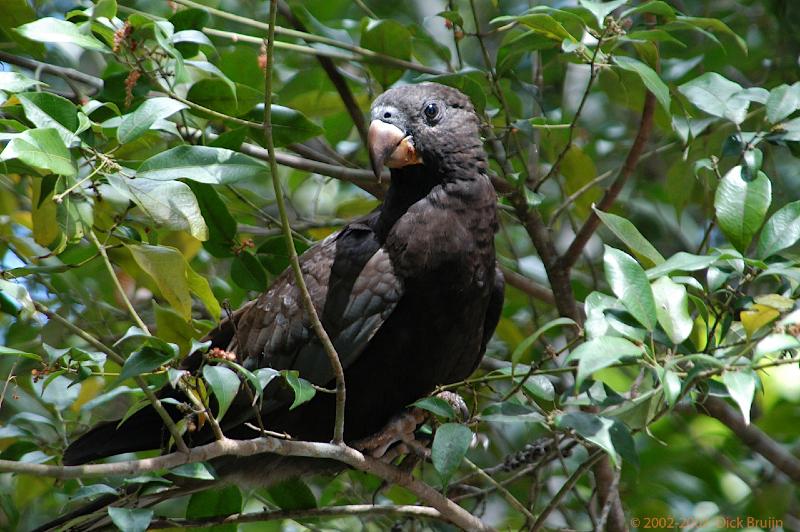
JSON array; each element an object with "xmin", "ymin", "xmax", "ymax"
[{"xmin": 264, "ymin": 0, "xmax": 347, "ymax": 445}]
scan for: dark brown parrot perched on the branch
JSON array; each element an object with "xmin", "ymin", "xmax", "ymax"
[{"xmin": 64, "ymin": 83, "xmax": 503, "ymax": 484}]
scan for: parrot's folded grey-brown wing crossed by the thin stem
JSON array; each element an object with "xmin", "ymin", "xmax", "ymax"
[{"xmin": 219, "ymin": 222, "xmax": 403, "ymax": 386}]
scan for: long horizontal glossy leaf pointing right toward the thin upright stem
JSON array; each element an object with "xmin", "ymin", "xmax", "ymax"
[{"xmin": 137, "ymin": 146, "xmax": 269, "ymax": 185}]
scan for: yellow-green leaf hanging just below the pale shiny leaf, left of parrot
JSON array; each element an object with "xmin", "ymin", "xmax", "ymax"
[{"xmin": 126, "ymin": 245, "xmax": 192, "ymax": 321}]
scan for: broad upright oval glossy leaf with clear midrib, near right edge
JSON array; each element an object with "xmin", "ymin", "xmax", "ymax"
[{"xmin": 714, "ymin": 166, "xmax": 772, "ymax": 252}]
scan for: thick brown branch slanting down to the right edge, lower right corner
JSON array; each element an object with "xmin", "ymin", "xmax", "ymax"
[{"xmin": 697, "ymin": 396, "xmax": 800, "ymax": 482}]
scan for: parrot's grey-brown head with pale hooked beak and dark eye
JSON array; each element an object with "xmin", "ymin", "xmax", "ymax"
[{"xmin": 368, "ymin": 83, "xmax": 486, "ymax": 177}]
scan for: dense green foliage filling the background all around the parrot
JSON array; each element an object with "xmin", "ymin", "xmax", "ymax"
[{"xmin": 0, "ymin": 0, "xmax": 800, "ymax": 530}]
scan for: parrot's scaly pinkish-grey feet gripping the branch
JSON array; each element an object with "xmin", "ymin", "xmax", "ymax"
[{"xmin": 354, "ymin": 392, "xmax": 469, "ymax": 461}]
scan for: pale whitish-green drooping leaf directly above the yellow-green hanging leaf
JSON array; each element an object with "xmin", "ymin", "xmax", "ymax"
[{"xmin": 107, "ymin": 174, "xmax": 208, "ymax": 240}]
